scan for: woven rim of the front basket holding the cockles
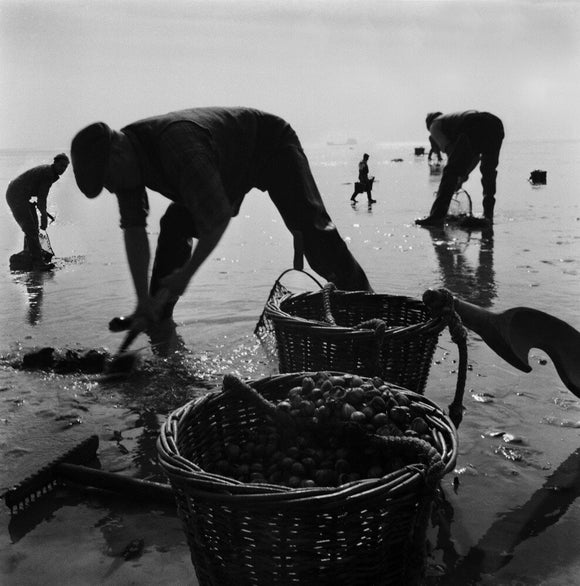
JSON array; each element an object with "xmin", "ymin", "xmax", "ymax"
[{"xmin": 157, "ymin": 371, "xmax": 458, "ymax": 509}]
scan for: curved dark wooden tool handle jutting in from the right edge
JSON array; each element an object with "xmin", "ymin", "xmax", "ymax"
[{"xmin": 423, "ymin": 289, "xmax": 580, "ymax": 397}]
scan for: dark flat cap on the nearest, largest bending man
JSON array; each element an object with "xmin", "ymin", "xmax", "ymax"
[{"xmin": 70, "ymin": 122, "xmax": 113, "ymax": 198}]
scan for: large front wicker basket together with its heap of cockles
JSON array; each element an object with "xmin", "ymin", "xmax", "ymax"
[{"xmin": 158, "ymin": 372, "xmax": 457, "ymax": 586}]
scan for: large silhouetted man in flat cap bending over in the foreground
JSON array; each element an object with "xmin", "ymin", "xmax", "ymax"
[{"xmin": 71, "ymin": 108, "xmax": 370, "ymax": 325}]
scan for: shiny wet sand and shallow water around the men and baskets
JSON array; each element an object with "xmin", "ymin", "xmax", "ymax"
[{"xmin": 0, "ymin": 142, "xmax": 580, "ymax": 585}]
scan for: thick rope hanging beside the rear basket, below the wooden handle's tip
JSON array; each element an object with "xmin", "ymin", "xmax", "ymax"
[{"xmin": 423, "ymin": 289, "xmax": 467, "ymax": 429}]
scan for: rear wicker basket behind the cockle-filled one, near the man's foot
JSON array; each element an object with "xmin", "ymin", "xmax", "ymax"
[{"xmin": 264, "ymin": 288, "xmax": 446, "ymax": 393}]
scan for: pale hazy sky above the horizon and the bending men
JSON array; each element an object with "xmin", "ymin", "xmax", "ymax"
[{"xmin": 0, "ymin": 0, "xmax": 580, "ymax": 149}]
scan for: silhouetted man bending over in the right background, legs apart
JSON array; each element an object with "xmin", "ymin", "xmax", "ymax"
[{"xmin": 415, "ymin": 110, "xmax": 505, "ymax": 226}]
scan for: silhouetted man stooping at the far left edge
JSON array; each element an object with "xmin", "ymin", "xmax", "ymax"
[{"xmin": 6, "ymin": 153, "xmax": 69, "ymax": 270}]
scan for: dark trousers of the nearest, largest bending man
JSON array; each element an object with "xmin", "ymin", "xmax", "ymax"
[{"xmin": 150, "ymin": 144, "xmax": 371, "ymax": 317}]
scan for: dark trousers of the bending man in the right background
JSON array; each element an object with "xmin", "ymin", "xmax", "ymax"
[{"xmin": 429, "ymin": 113, "xmax": 505, "ymax": 219}]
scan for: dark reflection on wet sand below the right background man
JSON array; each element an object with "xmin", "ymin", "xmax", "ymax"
[{"xmin": 429, "ymin": 225, "xmax": 497, "ymax": 307}]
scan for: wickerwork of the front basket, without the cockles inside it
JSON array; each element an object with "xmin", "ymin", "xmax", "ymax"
[{"xmin": 158, "ymin": 373, "xmax": 457, "ymax": 586}]
